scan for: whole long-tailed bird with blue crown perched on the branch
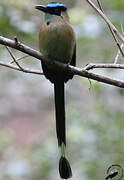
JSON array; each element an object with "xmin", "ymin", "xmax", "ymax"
[{"xmin": 35, "ymin": 2, "xmax": 76, "ymax": 179}]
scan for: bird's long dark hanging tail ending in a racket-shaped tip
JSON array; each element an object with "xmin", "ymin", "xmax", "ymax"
[{"xmin": 54, "ymin": 80, "xmax": 72, "ymax": 179}]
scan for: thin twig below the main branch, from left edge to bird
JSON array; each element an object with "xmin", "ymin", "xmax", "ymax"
[{"xmin": 0, "ymin": 61, "xmax": 43, "ymax": 75}]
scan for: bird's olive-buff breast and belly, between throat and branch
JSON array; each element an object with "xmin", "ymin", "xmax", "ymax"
[{"xmin": 39, "ymin": 17, "xmax": 75, "ymax": 63}]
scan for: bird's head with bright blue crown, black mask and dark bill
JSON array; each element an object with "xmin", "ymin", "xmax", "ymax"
[{"xmin": 35, "ymin": 2, "xmax": 67, "ymax": 16}]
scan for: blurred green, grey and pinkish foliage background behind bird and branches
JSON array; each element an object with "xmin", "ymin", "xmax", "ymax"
[{"xmin": 0, "ymin": 0, "xmax": 124, "ymax": 180}]
